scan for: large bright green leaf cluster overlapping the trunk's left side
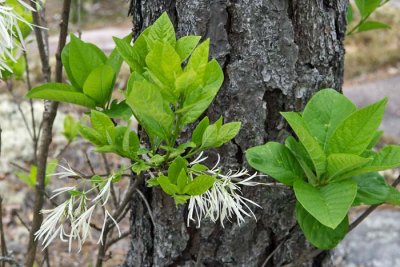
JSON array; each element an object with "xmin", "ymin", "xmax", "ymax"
[{"xmin": 28, "ymin": 13, "xmax": 240, "ymax": 204}]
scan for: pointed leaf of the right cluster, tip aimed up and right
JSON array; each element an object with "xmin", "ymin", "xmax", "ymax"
[{"xmin": 327, "ymin": 98, "xmax": 387, "ymax": 155}]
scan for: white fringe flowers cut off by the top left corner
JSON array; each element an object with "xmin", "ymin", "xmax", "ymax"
[{"xmin": 0, "ymin": 0, "xmax": 33, "ymax": 75}]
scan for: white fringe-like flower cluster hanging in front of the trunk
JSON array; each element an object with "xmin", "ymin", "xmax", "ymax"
[{"xmin": 187, "ymin": 154, "xmax": 262, "ymax": 227}]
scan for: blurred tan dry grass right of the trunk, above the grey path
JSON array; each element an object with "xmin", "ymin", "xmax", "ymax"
[{"xmin": 345, "ymin": 6, "xmax": 400, "ymax": 80}]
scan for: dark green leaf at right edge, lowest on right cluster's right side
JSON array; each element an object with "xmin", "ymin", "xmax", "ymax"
[{"xmin": 353, "ymin": 172, "xmax": 400, "ymax": 205}]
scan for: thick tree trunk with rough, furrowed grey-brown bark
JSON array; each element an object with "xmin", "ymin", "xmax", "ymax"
[{"xmin": 125, "ymin": 0, "xmax": 348, "ymax": 266}]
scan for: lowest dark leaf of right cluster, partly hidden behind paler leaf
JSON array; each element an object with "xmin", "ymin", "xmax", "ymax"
[{"xmin": 296, "ymin": 202, "xmax": 349, "ymax": 249}]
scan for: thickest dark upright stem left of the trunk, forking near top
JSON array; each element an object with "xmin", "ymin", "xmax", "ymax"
[{"xmin": 25, "ymin": 0, "xmax": 71, "ymax": 267}]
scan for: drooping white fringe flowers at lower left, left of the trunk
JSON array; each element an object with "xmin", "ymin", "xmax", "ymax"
[{"xmin": 35, "ymin": 166, "xmax": 121, "ymax": 251}]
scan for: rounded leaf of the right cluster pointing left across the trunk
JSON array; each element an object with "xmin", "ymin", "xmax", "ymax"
[{"xmin": 246, "ymin": 142, "xmax": 304, "ymax": 185}]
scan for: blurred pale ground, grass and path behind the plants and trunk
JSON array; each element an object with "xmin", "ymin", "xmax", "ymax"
[{"xmin": 0, "ymin": 0, "xmax": 400, "ymax": 267}]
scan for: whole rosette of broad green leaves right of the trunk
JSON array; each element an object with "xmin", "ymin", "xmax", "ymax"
[{"xmin": 246, "ymin": 89, "xmax": 400, "ymax": 249}]
